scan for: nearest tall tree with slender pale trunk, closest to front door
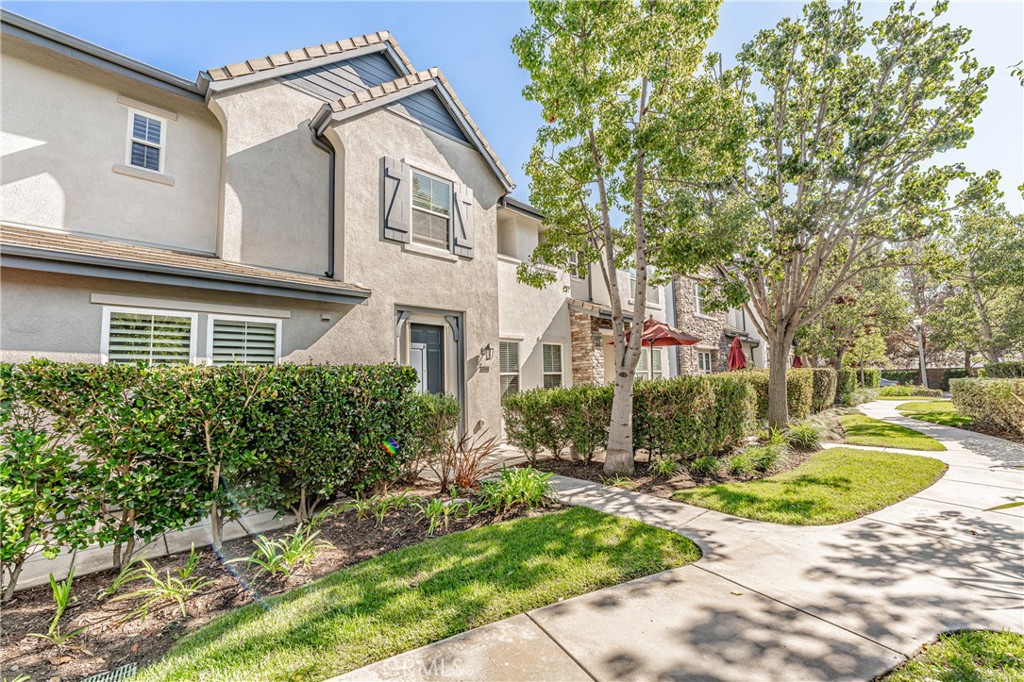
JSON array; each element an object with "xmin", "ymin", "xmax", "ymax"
[{"xmin": 512, "ymin": 0, "xmax": 741, "ymax": 474}]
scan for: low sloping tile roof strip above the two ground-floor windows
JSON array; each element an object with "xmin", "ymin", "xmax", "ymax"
[{"xmin": 0, "ymin": 225, "xmax": 370, "ymax": 298}]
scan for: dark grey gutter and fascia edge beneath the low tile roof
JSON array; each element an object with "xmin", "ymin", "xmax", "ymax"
[{"xmin": 0, "ymin": 244, "xmax": 371, "ymax": 305}]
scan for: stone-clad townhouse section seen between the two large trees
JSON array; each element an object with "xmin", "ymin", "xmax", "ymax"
[{"xmin": 672, "ymin": 275, "xmax": 768, "ymax": 374}]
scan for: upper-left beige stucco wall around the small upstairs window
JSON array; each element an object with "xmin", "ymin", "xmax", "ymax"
[{"xmin": 0, "ymin": 36, "xmax": 220, "ymax": 253}]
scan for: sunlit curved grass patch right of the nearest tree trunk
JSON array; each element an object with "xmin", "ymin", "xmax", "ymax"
[{"xmin": 672, "ymin": 447, "xmax": 945, "ymax": 525}]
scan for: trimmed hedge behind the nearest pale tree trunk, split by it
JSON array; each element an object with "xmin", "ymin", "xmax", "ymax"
[{"xmin": 503, "ymin": 373, "xmax": 756, "ymax": 462}]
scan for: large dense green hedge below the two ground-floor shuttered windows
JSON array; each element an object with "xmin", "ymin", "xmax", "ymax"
[{"xmin": 0, "ymin": 360, "xmax": 436, "ymax": 598}]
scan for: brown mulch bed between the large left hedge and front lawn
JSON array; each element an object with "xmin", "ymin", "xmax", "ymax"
[{"xmin": 0, "ymin": 482, "xmax": 553, "ymax": 680}]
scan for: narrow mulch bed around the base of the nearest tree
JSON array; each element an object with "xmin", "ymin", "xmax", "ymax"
[{"xmin": 532, "ymin": 452, "xmax": 813, "ymax": 498}]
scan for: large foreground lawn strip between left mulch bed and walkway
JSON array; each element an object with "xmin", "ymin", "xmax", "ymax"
[{"xmin": 138, "ymin": 508, "xmax": 700, "ymax": 681}]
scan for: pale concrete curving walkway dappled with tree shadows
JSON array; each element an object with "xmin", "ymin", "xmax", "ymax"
[{"xmin": 335, "ymin": 401, "xmax": 1024, "ymax": 682}]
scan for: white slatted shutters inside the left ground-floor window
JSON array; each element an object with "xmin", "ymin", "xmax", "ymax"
[{"xmin": 106, "ymin": 312, "xmax": 193, "ymax": 365}]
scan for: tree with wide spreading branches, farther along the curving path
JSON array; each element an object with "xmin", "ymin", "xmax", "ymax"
[{"xmin": 704, "ymin": 0, "xmax": 992, "ymax": 426}]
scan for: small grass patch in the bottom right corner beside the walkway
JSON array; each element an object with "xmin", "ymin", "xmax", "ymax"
[{"xmin": 882, "ymin": 631, "xmax": 1024, "ymax": 682}]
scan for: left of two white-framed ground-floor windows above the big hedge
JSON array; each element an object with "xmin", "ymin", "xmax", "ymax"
[{"xmin": 99, "ymin": 306, "xmax": 199, "ymax": 365}]
